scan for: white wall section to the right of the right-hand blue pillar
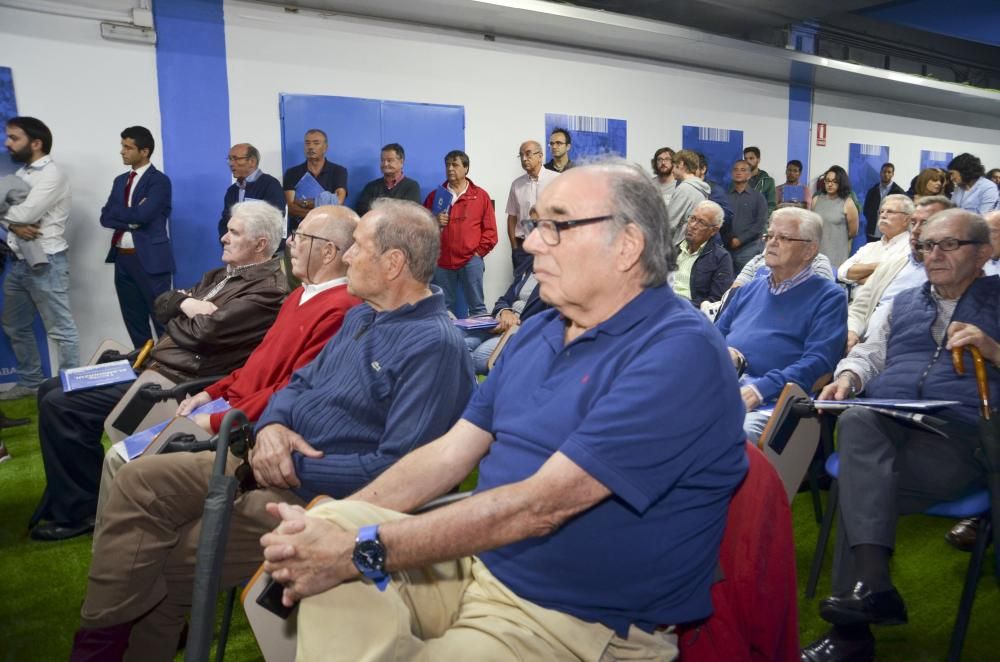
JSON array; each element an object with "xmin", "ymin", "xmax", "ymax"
[{"xmin": 809, "ymin": 91, "xmax": 1000, "ymax": 188}]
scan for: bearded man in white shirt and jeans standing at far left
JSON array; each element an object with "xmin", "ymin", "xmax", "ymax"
[{"xmin": 0, "ymin": 117, "xmax": 80, "ymax": 400}]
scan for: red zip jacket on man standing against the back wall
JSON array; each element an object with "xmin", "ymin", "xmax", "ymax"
[{"xmin": 424, "ymin": 179, "xmax": 497, "ymax": 269}]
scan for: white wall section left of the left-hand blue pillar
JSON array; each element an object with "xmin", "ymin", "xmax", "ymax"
[{"xmin": 0, "ymin": 7, "xmax": 162, "ymax": 360}]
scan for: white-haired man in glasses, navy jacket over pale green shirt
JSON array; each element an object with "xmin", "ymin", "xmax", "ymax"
[{"xmin": 672, "ymin": 200, "xmax": 733, "ymax": 308}]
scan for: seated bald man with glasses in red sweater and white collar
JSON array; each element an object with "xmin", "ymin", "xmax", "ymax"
[{"xmin": 97, "ymin": 206, "xmax": 361, "ymax": 517}]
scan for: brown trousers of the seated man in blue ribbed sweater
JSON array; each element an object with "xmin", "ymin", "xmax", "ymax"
[{"xmin": 80, "ymin": 452, "xmax": 303, "ymax": 662}]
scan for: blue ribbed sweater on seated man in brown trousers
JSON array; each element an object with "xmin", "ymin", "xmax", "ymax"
[{"xmin": 257, "ymin": 288, "xmax": 475, "ymax": 501}]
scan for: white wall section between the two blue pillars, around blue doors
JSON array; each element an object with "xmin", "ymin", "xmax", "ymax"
[{"xmin": 226, "ymin": 1, "xmax": 788, "ymax": 304}]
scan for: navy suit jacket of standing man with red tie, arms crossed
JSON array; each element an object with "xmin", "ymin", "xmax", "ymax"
[{"xmin": 101, "ymin": 165, "xmax": 174, "ymax": 274}]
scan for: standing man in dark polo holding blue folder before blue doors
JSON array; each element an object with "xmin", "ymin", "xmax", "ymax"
[{"xmin": 282, "ymin": 129, "xmax": 347, "ymax": 235}]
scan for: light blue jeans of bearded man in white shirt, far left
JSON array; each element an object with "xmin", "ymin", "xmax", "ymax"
[{"xmin": 3, "ymin": 251, "xmax": 80, "ymax": 388}]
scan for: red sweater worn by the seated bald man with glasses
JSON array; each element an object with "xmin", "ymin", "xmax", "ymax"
[{"xmin": 205, "ymin": 284, "xmax": 361, "ymax": 432}]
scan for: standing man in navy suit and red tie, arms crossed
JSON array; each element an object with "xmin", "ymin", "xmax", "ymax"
[{"xmin": 101, "ymin": 126, "xmax": 174, "ymax": 348}]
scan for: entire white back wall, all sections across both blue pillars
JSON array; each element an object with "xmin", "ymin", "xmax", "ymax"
[{"xmin": 0, "ymin": 0, "xmax": 1000, "ymax": 364}]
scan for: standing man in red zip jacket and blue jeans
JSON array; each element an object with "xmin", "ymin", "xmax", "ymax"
[{"xmin": 424, "ymin": 149, "xmax": 497, "ymax": 316}]
